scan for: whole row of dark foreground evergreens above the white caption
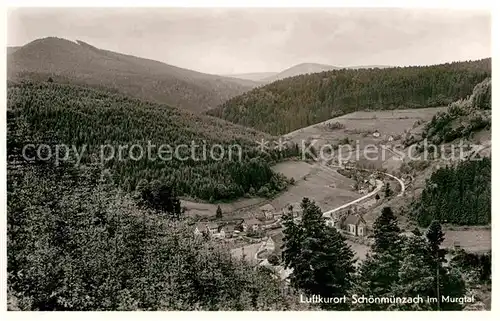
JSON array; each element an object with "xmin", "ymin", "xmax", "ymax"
[{"xmin": 281, "ymin": 199, "xmax": 491, "ymax": 311}]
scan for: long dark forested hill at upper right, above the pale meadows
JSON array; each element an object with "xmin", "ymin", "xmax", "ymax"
[{"xmin": 208, "ymin": 58, "xmax": 491, "ymax": 134}]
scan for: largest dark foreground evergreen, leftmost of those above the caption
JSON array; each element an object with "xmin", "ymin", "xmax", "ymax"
[{"xmin": 282, "ymin": 198, "xmax": 355, "ymax": 310}]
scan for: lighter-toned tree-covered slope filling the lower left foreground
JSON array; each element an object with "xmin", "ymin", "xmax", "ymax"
[{"xmin": 7, "ymin": 159, "xmax": 307, "ymax": 311}]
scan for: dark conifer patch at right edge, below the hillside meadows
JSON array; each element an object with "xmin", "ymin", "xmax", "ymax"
[{"xmin": 412, "ymin": 158, "xmax": 491, "ymax": 226}]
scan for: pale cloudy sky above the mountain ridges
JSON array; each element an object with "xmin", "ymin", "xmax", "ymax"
[{"xmin": 7, "ymin": 8, "xmax": 491, "ymax": 74}]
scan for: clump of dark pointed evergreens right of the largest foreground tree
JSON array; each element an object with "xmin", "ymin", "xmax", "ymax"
[{"xmin": 354, "ymin": 215, "xmax": 465, "ymax": 311}]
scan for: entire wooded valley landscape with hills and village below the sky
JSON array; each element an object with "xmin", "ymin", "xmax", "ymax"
[{"xmin": 7, "ymin": 28, "xmax": 492, "ymax": 310}]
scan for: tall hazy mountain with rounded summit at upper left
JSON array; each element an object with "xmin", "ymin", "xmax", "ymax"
[{"xmin": 7, "ymin": 37, "xmax": 256, "ymax": 112}]
